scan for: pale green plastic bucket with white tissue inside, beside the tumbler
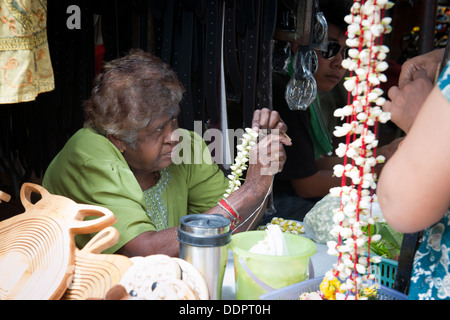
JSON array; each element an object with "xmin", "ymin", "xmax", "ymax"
[{"xmin": 230, "ymin": 230, "xmax": 317, "ymax": 300}]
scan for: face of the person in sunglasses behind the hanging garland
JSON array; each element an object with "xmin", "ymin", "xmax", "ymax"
[{"xmin": 314, "ymin": 23, "xmax": 347, "ymax": 91}]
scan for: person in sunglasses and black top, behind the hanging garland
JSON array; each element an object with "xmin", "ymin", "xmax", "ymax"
[{"xmin": 262, "ymin": 0, "xmax": 396, "ymax": 224}]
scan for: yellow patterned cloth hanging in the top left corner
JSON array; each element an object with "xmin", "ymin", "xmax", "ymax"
[{"xmin": 0, "ymin": 0, "xmax": 55, "ymax": 103}]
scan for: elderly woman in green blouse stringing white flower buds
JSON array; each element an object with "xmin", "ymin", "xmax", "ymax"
[{"xmin": 43, "ymin": 51, "xmax": 290, "ymax": 256}]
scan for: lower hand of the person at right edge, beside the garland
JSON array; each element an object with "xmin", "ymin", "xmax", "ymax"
[{"xmin": 383, "ymin": 69, "xmax": 433, "ymax": 133}]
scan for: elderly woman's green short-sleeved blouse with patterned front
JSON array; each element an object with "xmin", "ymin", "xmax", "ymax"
[{"xmin": 43, "ymin": 128, "xmax": 228, "ymax": 253}]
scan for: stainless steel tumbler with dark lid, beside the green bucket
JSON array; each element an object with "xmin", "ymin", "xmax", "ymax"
[{"xmin": 177, "ymin": 214, "xmax": 231, "ymax": 300}]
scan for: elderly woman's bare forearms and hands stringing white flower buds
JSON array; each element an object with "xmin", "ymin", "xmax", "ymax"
[{"xmin": 117, "ymin": 109, "xmax": 291, "ymax": 257}]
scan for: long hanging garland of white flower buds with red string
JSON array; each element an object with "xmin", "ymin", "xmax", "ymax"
[{"xmin": 316, "ymin": 0, "xmax": 393, "ymax": 299}]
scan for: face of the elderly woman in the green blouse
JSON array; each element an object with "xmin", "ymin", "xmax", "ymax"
[{"xmin": 123, "ymin": 107, "xmax": 180, "ymax": 172}]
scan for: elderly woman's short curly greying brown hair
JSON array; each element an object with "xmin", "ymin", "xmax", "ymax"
[{"xmin": 83, "ymin": 50, "xmax": 185, "ymax": 149}]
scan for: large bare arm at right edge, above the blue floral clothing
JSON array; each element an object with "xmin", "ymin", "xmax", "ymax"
[{"xmin": 377, "ymin": 87, "xmax": 450, "ymax": 233}]
